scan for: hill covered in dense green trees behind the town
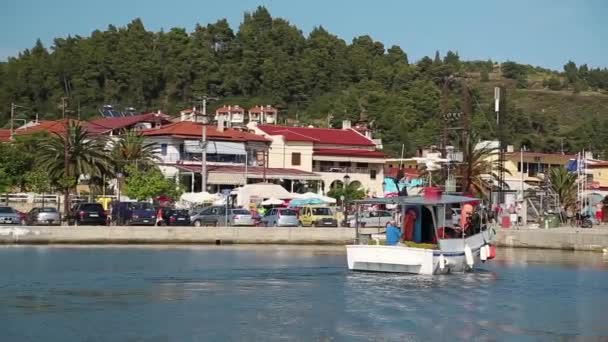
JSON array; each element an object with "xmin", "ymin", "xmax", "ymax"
[{"xmin": 0, "ymin": 7, "xmax": 608, "ymax": 153}]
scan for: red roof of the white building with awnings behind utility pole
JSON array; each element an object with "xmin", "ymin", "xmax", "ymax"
[{"xmin": 142, "ymin": 121, "xmax": 269, "ymax": 142}]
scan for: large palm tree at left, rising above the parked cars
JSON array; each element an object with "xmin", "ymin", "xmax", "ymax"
[{"xmin": 38, "ymin": 122, "xmax": 112, "ymax": 213}]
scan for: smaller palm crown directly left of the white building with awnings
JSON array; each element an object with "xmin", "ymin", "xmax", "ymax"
[{"xmin": 112, "ymin": 130, "xmax": 159, "ymax": 171}]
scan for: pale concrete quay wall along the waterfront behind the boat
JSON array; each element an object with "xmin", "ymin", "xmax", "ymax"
[{"xmin": 0, "ymin": 226, "xmax": 608, "ymax": 251}]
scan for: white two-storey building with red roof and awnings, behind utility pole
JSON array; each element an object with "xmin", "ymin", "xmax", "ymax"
[{"xmin": 142, "ymin": 120, "xmax": 320, "ymax": 192}]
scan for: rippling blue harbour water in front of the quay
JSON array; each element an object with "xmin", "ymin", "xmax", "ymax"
[{"xmin": 0, "ymin": 246, "xmax": 608, "ymax": 341}]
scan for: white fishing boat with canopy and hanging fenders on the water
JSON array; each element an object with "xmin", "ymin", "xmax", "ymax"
[{"xmin": 346, "ymin": 194, "xmax": 496, "ymax": 275}]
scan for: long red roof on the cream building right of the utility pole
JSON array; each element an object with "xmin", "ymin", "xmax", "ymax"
[{"xmin": 258, "ymin": 125, "xmax": 375, "ymax": 146}]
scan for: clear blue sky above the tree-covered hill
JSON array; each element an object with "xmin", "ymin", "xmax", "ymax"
[{"xmin": 0, "ymin": 0, "xmax": 608, "ymax": 70}]
